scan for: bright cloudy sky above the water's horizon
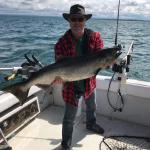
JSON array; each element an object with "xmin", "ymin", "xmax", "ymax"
[{"xmin": 0, "ymin": 0, "xmax": 150, "ymax": 20}]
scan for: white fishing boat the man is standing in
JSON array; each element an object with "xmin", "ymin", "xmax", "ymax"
[{"xmin": 0, "ymin": 42, "xmax": 150, "ymax": 150}]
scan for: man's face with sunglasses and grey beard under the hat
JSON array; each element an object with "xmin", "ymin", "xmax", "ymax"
[{"xmin": 69, "ymin": 17, "xmax": 86, "ymax": 37}]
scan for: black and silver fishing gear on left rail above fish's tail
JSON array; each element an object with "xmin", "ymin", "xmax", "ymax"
[{"xmin": 4, "ymin": 54, "xmax": 43, "ymax": 81}]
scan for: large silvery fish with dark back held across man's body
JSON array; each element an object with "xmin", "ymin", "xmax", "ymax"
[{"xmin": 3, "ymin": 46, "xmax": 121, "ymax": 103}]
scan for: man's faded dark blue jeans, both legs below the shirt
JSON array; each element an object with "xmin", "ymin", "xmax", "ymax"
[{"xmin": 61, "ymin": 92, "xmax": 96, "ymax": 148}]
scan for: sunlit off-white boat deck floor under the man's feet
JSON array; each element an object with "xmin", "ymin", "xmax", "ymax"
[{"xmin": 8, "ymin": 105, "xmax": 150, "ymax": 150}]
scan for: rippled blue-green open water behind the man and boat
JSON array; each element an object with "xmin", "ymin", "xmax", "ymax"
[{"xmin": 0, "ymin": 15, "xmax": 150, "ymax": 88}]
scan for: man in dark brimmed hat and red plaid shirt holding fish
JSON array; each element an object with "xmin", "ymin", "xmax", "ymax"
[{"xmin": 55, "ymin": 4, "xmax": 104, "ymax": 150}]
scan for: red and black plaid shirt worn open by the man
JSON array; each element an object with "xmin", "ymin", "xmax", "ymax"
[{"xmin": 55, "ymin": 30, "xmax": 103, "ymax": 106}]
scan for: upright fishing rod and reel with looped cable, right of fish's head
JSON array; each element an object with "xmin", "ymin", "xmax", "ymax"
[{"xmin": 107, "ymin": 0, "xmax": 133, "ymax": 112}]
